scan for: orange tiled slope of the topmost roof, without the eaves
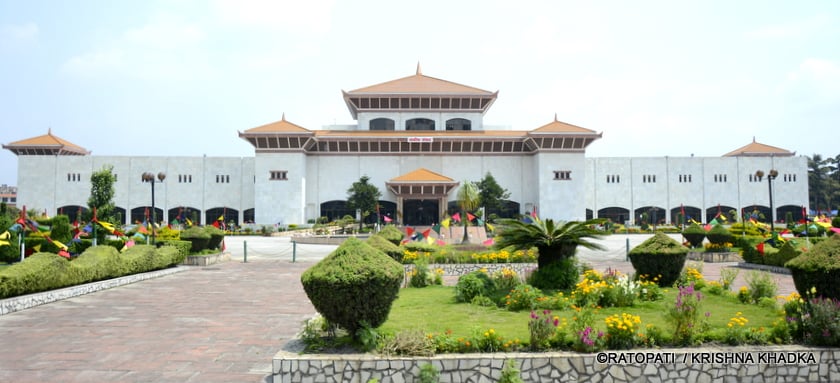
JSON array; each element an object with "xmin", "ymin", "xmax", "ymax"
[{"xmin": 347, "ymin": 64, "xmax": 494, "ymax": 96}]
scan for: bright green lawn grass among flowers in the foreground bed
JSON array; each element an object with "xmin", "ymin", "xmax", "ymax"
[{"xmin": 380, "ymin": 286, "xmax": 783, "ymax": 341}]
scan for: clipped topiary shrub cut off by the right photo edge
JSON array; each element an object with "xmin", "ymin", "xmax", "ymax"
[{"xmin": 785, "ymin": 235, "xmax": 840, "ymax": 299}]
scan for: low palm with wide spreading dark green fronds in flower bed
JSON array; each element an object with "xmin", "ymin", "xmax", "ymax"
[{"xmin": 495, "ymin": 217, "xmax": 606, "ymax": 268}]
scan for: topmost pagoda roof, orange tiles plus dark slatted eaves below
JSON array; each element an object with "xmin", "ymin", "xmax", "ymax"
[{"xmin": 342, "ymin": 64, "xmax": 499, "ymax": 119}]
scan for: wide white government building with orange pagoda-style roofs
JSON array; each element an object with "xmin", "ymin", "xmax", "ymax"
[{"xmin": 3, "ymin": 65, "xmax": 808, "ymax": 225}]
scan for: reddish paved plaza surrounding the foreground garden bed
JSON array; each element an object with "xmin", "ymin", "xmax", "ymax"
[{"xmin": 0, "ymin": 235, "xmax": 794, "ymax": 382}]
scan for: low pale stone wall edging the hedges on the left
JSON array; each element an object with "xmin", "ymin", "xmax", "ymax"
[{"xmin": 0, "ymin": 267, "xmax": 189, "ymax": 315}]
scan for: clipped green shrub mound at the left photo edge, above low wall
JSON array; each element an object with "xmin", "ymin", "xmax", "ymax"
[{"xmin": 0, "ymin": 253, "xmax": 70, "ymax": 298}]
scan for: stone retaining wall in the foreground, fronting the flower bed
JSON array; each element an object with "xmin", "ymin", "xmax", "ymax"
[{"xmin": 272, "ymin": 346, "xmax": 840, "ymax": 383}]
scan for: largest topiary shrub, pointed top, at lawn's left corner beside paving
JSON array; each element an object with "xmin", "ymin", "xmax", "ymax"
[{"xmin": 300, "ymin": 238, "xmax": 403, "ymax": 337}]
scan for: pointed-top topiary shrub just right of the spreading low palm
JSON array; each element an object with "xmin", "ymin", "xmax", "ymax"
[{"xmin": 629, "ymin": 233, "xmax": 688, "ymax": 287}]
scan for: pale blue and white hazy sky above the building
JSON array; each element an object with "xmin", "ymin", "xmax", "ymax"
[{"xmin": 0, "ymin": 0, "xmax": 840, "ymax": 185}]
